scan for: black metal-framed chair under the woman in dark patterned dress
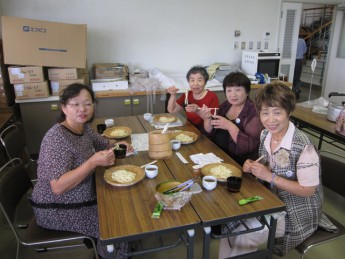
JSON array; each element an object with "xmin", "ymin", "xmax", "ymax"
[{"xmin": 0, "ymin": 158, "xmax": 98, "ymax": 259}]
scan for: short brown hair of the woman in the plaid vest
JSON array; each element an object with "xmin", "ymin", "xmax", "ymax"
[{"xmin": 255, "ymin": 81, "xmax": 296, "ymax": 114}]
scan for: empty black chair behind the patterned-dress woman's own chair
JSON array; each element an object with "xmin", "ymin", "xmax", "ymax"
[{"xmin": 0, "ymin": 124, "xmax": 37, "ymax": 181}]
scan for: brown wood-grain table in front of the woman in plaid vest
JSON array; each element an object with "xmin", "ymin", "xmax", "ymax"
[{"xmin": 138, "ymin": 116, "xmax": 285, "ymax": 259}]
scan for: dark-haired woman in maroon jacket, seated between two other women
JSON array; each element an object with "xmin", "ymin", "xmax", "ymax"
[{"xmin": 200, "ymin": 72, "xmax": 263, "ymax": 165}]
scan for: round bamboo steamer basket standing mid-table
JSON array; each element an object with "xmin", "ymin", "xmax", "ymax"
[{"xmin": 149, "ymin": 130, "xmax": 172, "ymax": 159}]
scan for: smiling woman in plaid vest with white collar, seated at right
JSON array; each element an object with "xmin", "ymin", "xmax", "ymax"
[{"xmin": 219, "ymin": 82, "xmax": 337, "ymax": 258}]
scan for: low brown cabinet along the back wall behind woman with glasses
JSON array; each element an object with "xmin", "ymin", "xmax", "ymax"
[{"xmin": 16, "ymin": 91, "xmax": 166, "ymax": 155}]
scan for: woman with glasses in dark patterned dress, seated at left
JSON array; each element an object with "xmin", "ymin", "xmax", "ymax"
[{"xmin": 32, "ymin": 84, "xmax": 131, "ymax": 258}]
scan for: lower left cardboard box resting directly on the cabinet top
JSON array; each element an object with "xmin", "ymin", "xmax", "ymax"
[{"xmin": 13, "ymin": 81, "xmax": 49, "ymax": 100}]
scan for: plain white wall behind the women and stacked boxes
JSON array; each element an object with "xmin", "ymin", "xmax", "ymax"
[{"xmin": 0, "ymin": 0, "xmax": 281, "ymax": 73}]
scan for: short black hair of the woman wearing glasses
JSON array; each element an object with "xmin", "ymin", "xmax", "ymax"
[{"xmin": 58, "ymin": 83, "xmax": 96, "ymax": 122}]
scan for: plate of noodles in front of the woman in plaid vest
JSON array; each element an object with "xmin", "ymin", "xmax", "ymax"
[{"xmin": 201, "ymin": 163, "xmax": 242, "ymax": 182}]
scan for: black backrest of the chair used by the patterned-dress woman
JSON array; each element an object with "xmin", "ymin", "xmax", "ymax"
[{"xmin": 0, "ymin": 158, "xmax": 32, "ymax": 225}]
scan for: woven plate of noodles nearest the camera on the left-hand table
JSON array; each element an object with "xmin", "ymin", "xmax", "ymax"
[{"xmin": 104, "ymin": 165, "xmax": 145, "ymax": 187}]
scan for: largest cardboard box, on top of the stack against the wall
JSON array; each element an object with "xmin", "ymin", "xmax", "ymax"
[{"xmin": 1, "ymin": 16, "xmax": 87, "ymax": 68}]
